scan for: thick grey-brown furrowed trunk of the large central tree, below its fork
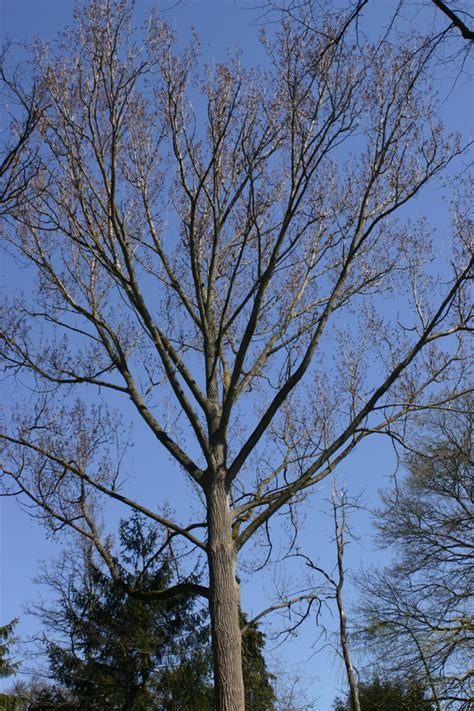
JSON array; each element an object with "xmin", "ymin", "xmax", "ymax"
[{"xmin": 206, "ymin": 479, "xmax": 245, "ymax": 711}]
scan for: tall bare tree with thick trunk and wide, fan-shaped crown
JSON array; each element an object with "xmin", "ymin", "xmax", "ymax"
[{"xmin": 0, "ymin": 0, "xmax": 472, "ymax": 711}]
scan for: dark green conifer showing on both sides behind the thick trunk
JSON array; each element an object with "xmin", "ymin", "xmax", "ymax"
[{"xmin": 30, "ymin": 515, "xmax": 275, "ymax": 711}]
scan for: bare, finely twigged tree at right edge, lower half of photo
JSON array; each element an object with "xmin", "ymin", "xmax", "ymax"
[{"xmin": 362, "ymin": 398, "xmax": 474, "ymax": 709}]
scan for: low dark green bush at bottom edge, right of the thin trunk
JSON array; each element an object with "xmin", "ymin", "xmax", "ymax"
[{"xmin": 334, "ymin": 676, "xmax": 434, "ymax": 711}]
